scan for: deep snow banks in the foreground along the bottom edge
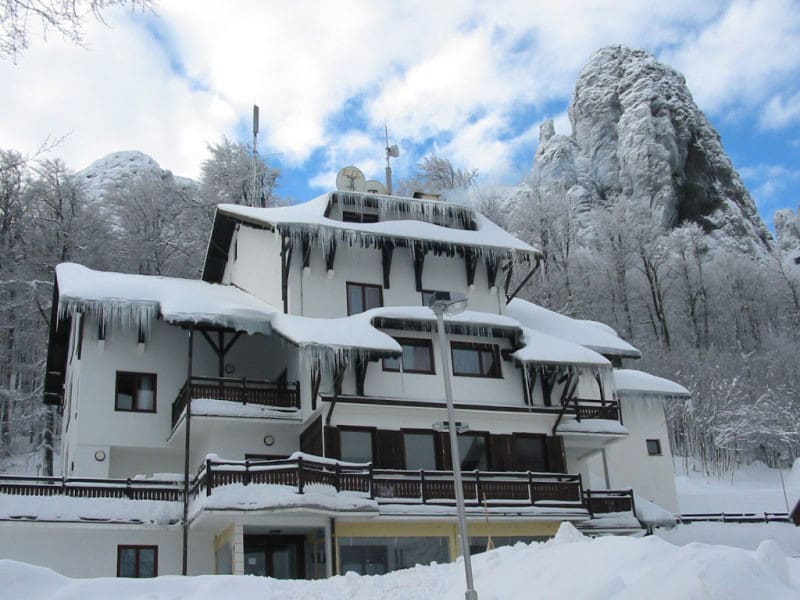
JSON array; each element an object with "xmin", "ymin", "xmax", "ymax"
[{"xmin": 0, "ymin": 524, "xmax": 800, "ymax": 600}]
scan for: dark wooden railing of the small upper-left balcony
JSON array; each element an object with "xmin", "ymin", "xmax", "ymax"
[{"xmin": 172, "ymin": 377, "xmax": 300, "ymax": 427}]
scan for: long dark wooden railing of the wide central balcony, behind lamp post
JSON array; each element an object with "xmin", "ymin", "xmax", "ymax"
[{"xmin": 191, "ymin": 457, "xmax": 583, "ymax": 508}]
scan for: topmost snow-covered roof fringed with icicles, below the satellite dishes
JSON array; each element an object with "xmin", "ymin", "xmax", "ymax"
[{"xmin": 217, "ymin": 192, "xmax": 540, "ymax": 256}]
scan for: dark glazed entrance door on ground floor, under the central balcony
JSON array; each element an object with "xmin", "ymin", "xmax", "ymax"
[{"xmin": 244, "ymin": 535, "xmax": 306, "ymax": 579}]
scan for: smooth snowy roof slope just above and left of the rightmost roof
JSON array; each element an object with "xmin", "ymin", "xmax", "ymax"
[{"xmin": 506, "ymin": 298, "xmax": 642, "ymax": 358}]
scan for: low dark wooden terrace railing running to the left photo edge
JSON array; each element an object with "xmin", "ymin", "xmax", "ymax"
[{"xmin": 0, "ymin": 475, "xmax": 183, "ymax": 502}]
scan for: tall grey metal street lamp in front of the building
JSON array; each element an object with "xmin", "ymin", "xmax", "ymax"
[{"xmin": 430, "ymin": 294, "xmax": 478, "ymax": 600}]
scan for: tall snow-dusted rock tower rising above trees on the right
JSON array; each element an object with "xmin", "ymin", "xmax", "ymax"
[{"xmin": 531, "ymin": 46, "xmax": 771, "ymax": 254}]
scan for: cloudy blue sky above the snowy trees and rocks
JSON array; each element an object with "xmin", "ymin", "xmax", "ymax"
[{"xmin": 0, "ymin": 0, "xmax": 800, "ymax": 225}]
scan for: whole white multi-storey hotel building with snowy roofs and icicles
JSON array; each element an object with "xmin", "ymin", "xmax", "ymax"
[{"xmin": 0, "ymin": 191, "xmax": 688, "ymax": 578}]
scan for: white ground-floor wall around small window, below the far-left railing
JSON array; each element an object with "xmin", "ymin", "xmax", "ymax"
[{"xmin": 0, "ymin": 521, "xmax": 214, "ymax": 577}]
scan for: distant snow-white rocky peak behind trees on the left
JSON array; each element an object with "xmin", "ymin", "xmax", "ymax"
[{"xmin": 78, "ymin": 150, "xmax": 199, "ymax": 199}]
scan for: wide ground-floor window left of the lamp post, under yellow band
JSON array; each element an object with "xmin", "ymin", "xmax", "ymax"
[{"xmin": 338, "ymin": 537, "xmax": 450, "ymax": 575}]
